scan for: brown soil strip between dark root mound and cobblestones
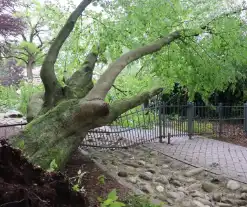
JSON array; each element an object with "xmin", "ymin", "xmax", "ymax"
[{"xmin": 63, "ymin": 151, "xmax": 129, "ymax": 206}]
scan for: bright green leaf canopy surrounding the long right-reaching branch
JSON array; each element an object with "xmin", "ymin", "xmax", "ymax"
[{"xmin": 88, "ymin": 0, "xmax": 247, "ymax": 97}]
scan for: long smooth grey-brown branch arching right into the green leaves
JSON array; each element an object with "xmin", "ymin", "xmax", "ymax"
[{"xmin": 86, "ymin": 31, "xmax": 182, "ymax": 100}]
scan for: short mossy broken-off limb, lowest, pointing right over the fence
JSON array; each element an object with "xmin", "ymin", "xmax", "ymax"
[{"xmin": 107, "ymin": 88, "xmax": 163, "ymax": 122}]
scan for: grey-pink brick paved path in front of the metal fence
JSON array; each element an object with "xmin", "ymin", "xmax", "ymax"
[{"xmin": 145, "ymin": 136, "xmax": 247, "ymax": 183}]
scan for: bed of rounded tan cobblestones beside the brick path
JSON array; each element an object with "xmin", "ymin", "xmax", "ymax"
[{"xmin": 83, "ymin": 146, "xmax": 247, "ymax": 207}]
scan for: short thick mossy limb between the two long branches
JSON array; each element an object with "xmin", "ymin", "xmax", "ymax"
[{"xmin": 65, "ymin": 52, "xmax": 98, "ymax": 98}]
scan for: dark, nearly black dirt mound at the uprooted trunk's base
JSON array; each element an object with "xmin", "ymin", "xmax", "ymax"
[{"xmin": 0, "ymin": 140, "xmax": 89, "ymax": 207}]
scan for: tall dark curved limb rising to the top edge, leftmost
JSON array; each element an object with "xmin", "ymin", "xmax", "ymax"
[{"xmin": 40, "ymin": 0, "xmax": 92, "ymax": 108}]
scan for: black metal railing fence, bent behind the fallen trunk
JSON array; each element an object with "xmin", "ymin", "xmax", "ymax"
[{"xmin": 0, "ymin": 101, "xmax": 247, "ymax": 148}]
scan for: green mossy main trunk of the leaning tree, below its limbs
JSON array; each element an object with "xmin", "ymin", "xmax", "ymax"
[{"xmin": 11, "ymin": 100, "xmax": 90, "ymax": 169}]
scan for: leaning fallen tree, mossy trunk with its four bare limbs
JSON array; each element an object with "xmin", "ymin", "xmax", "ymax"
[{"xmin": 11, "ymin": 0, "xmax": 245, "ymax": 169}]
